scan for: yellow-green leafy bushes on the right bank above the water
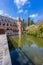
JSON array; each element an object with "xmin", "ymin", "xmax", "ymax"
[{"xmin": 27, "ymin": 25, "xmax": 43, "ymax": 37}]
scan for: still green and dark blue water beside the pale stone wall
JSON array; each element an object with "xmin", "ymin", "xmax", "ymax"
[{"xmin": 10, "ymin": 35, "xmax": 43, "ymax": 65}]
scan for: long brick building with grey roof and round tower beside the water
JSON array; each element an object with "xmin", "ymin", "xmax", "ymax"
[{"xmin": 0, "ymin": 15, "xmax": 22, "ymax": 35}]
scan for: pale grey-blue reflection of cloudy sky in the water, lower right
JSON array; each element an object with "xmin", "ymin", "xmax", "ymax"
[{"xmin": 22, "ymin": 44, "xmax": 43, "ymax": 65}]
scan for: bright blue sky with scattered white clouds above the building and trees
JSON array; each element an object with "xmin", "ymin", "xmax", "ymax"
[{"xmin": 0, "ymin": 0, "xmax": 43, "ymax": 21}]
